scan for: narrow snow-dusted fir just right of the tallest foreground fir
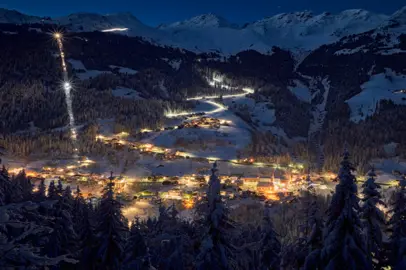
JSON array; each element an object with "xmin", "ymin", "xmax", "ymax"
[{"xmin": 361, "ymin": 168, "xmax": 385, "ymax": 269}]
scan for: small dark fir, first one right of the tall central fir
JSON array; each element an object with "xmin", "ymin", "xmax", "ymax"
[{"xmin": 260, "ymin": 207, "xmax": 281, "ymax": 270}]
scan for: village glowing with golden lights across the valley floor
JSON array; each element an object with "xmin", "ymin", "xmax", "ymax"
[{"xmin": 9, "ymin": 150, "xmax": 335, "ymax": 215}]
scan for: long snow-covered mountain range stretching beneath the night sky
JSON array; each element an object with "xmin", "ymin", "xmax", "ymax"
[{"xmin": 0, "ymin": 7, "xmax": 406, "ymax": 55}]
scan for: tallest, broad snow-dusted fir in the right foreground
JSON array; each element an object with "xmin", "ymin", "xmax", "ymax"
[{"xmin": 321, "ymin": 151, "xmax": 372, "ymax": 270}]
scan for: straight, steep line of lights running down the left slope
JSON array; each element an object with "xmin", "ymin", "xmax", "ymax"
[{"xmin": 53, "ymin": 32, "xmax": 78, "ymax": 152}]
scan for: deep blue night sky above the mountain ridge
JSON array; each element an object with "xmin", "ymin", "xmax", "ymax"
[{"xmin": 0, "ymin": 0, "xmax": 406, "ymax": 26}]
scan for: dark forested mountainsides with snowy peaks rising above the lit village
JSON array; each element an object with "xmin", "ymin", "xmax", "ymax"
[{"xmin": 0, "ymin": 8, "xmax": 406, "ymax": 173}]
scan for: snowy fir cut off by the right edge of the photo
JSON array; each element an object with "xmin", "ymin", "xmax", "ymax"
[{"xmin": 389, "ymin": 177, "xmax": 406, "ymax": 270}]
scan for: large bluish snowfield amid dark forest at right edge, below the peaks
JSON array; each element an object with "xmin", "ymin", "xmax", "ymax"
[{"xmin": 346, "ymin": 69, "xmax": 406, "ymax": 123}]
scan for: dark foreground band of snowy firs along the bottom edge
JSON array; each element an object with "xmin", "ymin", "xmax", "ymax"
[{"xmin": 0, "ymin": 152, "xmax": 406, "ymax": 270}]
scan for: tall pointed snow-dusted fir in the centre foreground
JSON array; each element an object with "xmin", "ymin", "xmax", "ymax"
[{"xmin": 197, "ymin": 162, "xmax": 235, "ymax": 270}]
